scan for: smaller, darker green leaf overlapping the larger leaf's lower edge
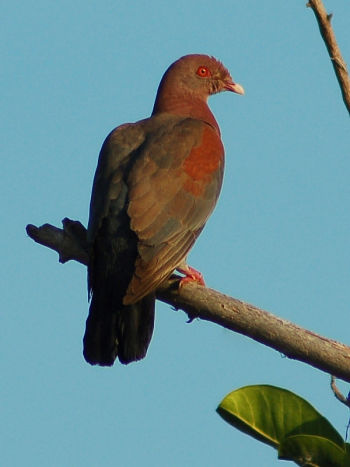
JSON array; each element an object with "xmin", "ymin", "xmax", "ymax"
[{"xmin": 278, "ymin": 435, "xmax": 349, "ymax": 467}]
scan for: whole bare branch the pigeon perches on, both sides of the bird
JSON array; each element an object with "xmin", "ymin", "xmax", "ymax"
[{"xmin": 27, "ymin": 218, "xmax": 350, "ymax": 382}]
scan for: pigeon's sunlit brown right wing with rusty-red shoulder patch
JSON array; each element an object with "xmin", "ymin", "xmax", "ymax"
[{"xmin": 124, "ymin": 118, "xmax": 224, "ymax": 304}]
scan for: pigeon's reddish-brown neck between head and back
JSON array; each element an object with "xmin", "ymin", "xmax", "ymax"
[{"xmin": 152, "ymin": 92, "xmax": 220, "ymax": 135}]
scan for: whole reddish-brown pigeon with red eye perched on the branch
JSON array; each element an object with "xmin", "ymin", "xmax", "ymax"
[{"xmin": 83, "ymin": 54, "xmax": 244, "ymax": 366}]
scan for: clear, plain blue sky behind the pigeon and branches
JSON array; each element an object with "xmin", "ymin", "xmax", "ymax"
[{"xmin": 0, "ymin": 0, "xmax": 350, "ymax": 467}]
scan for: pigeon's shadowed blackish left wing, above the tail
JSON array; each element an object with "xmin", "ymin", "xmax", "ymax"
[{"xmin": 87, "ymin": 121, "xmax": 145, "ymax": 302}]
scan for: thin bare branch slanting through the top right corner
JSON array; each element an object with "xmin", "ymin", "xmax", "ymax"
[{"xmin": 306, "ymin": 0, "xmax": 350, "ymax": 114}]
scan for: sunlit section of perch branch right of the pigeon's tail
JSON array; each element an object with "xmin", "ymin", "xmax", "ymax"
[{"xmin": 157, "ymin": 284, "xmax": 350, "ymax": 382}]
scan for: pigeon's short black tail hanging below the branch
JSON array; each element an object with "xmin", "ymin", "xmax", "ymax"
[{"xmin": 84, "ymin": 294, "xmax": 155, "ymax": 366}]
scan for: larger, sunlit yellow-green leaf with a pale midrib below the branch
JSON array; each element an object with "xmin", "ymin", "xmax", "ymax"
[{"xmin": 217, "ymin": 385, "xmax": 344, "ymax": 449}]
